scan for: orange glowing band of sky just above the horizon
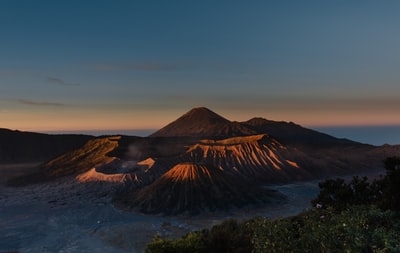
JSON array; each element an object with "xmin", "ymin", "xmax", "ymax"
[{"xmin": 0, "ymin": 106, "xmax": 400, "ymax": 132}]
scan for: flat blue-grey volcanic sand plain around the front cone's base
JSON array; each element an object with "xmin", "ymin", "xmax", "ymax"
[{"xmin": 0, "ymin": 178, "xmax": 318, "ymax": 253}]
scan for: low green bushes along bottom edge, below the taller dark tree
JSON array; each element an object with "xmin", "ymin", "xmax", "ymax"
[{"xmin": 146, "ymin": 206, "xmax": 400, "ymax": 253}]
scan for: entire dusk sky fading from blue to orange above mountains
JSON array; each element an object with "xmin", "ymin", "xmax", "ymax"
[{"xmin": 0, "ymin": 0, "xmax": 400, "ymax": 131}]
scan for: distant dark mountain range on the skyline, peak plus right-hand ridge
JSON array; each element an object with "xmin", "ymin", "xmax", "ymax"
[{"xmin": 150, "ymin": 107, "xmax": 356, "ymax": 145}]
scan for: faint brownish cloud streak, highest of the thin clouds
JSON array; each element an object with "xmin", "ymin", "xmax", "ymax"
[{"xmin": 94, "ymin": 63, "xmax": 179, "ymax": 71}]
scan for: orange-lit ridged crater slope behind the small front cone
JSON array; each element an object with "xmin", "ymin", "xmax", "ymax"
[{"xmin": 187, "ymin": 134, "xmax": 311, "ymax": 181}]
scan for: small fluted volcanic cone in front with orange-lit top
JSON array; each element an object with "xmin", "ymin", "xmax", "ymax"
[{"xmin": 115, "ymin": 163, "xmax": 283, "ymax": 215}]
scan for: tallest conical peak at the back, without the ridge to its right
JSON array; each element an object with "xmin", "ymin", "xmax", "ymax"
[{"xmin": 150, "ymin": 107, "xmax": 256, "ymax": 138}]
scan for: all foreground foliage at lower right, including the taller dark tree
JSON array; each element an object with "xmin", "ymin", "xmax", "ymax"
[{"xmin": 146, "ymin": 158, "xmax": 400, "ymax": 253}]
